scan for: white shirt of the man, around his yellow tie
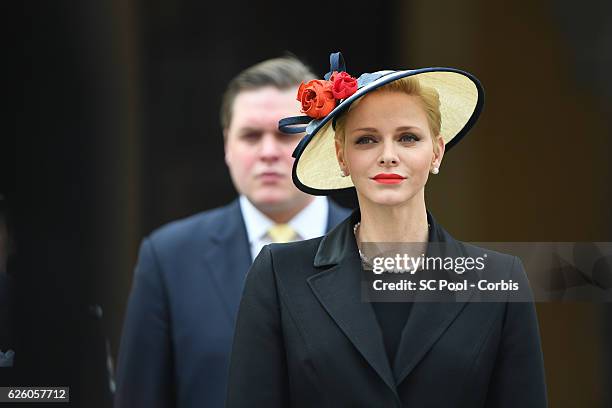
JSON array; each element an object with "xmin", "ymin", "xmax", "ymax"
[{"xmin": 240, "ymin": 195, "xmax": 329, "ymax": 259}]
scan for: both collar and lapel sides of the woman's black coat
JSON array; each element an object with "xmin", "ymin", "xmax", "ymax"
[{"xmin": 308, "ymin": 210, "xmax": 474, "ymax": 390}]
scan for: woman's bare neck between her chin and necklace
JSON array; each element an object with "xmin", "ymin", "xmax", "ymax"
[{"xmin": 359, "ymin": 197, "xmax": 429, "ymax": 242}]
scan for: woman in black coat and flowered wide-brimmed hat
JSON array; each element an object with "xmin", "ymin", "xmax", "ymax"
[{"xmin": 227, "ymin": 53, "xmax": 546, "ymax": 408}]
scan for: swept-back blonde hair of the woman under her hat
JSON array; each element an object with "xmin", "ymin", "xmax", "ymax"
[{"xmin": 335, "ymin": 77, "xmax": 442, "ymax": 154}]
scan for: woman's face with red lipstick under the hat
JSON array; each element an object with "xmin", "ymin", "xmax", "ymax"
[{"xmin": 336, "ymin": 91, "xmax": 444, "ymax": 206}]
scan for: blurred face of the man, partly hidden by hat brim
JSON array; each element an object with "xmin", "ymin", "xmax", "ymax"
[{"xmin": 225, "ymin": 86, "xmax": 311, "ymax": 213}]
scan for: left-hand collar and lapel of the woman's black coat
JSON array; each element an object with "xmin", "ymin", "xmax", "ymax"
[{"xmin": 308, "ymin": 210, "xmax": 396, "ymax": 392}]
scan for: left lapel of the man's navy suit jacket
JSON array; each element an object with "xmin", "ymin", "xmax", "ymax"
[{"xmin": 202, "ymin": 200, "xmax": 251, "ymax": 324}]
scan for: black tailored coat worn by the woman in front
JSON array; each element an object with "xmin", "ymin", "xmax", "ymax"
[{"xmin": 226, "ymin": 213, "xmax": 547, "ymax": 408}]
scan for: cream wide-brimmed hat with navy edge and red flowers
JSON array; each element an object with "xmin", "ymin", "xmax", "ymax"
[{"xmin": 278, "ymin": 52, "xmax": 484, "ymax": 195}]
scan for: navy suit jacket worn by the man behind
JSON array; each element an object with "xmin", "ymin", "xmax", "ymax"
[{"xmin": 115, "ymin": 200, "xmax": 349, "ymax": 408}]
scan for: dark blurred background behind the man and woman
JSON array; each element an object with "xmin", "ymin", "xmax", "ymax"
[{"xmin": 8, "ymin": 0, "xmax": 612, "ymax": 407}]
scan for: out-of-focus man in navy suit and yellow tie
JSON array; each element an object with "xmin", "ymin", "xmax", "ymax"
[{"xmin": 115, "ymin": 57, "xmax": 348, "ymax": 408}]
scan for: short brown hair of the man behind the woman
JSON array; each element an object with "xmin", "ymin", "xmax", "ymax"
[{"xmin": 221, "ymin": 56, "xmax": 316, "ymax": 130}]
